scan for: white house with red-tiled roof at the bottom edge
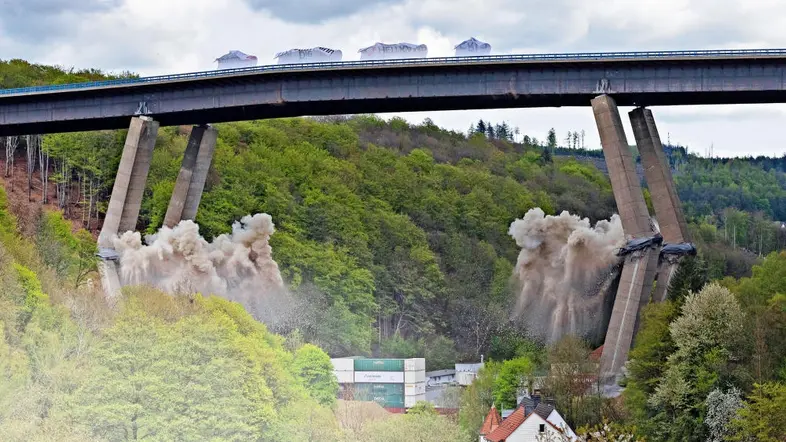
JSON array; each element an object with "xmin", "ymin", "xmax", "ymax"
[{"xmin": 479, "ymin": 403, "xmax": 578, "ymax": 442}]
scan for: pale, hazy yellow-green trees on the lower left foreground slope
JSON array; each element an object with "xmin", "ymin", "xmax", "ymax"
[{"xmin": 0, "ymin": 188, "xmax": 466, "ymax": 442}]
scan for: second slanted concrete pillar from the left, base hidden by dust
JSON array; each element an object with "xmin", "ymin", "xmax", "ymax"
[{"xmin": 164, "ymin": 126, "xmax": 218, "ymax": 227}]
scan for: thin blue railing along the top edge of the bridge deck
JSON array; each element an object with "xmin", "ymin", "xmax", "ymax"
[{"xmin": 0, "ymin": 49, "xmax": 786, "ymax": 96}]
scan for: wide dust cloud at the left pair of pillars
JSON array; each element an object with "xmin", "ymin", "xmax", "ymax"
[{"xmin": 108, "ymin": 213, "xmax": 285, "ymax": 317}]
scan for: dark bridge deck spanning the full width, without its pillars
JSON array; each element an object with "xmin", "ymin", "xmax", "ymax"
[{"xmin": 0, "ymin": 49, "xmax": 786, "ymax": 136}]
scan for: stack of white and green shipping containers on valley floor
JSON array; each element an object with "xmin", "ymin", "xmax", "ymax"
[{"xmin": 332, "ymin": 358, "xmax": 426, "ymax": 409}]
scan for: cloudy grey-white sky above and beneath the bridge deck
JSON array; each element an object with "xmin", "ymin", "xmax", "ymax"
[{"xmin": 0, "ymin": 0, "xmax": 786, "ymax": 156}]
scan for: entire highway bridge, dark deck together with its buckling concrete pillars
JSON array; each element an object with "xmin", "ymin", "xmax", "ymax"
[{"xmin": 0, "ymin": 49, "xmax": 786, "ymax": 385}]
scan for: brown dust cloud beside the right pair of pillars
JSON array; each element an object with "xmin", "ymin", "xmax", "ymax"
[{"xmin": 508, "ymin": 208, "xmax": 625, "ymax": 342}]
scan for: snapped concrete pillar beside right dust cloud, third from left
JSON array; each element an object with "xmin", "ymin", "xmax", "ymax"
[{"xmin": 592, "ymin": 95, "xmax": 659, "ymax": 384}]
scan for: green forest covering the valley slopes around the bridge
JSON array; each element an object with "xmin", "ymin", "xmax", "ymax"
[{"xmin": 0, "ymin": 60, "xmax": 786, "ymax": 441}]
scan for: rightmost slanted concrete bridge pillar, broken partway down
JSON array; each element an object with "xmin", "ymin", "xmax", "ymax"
[{"xmin": 629, "ymin": 108, "xmax": 689, "ymax": 302}]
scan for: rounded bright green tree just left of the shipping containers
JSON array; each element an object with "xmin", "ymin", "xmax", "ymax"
[{"xmin": 293, "ymin": 344, "xmax": 338, "ymax": 405}]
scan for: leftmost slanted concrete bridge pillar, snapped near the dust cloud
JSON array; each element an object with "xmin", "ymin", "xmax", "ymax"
[{"xmin": 98, "ymin": 116, "xmax": 159, "ymax": 302}]
